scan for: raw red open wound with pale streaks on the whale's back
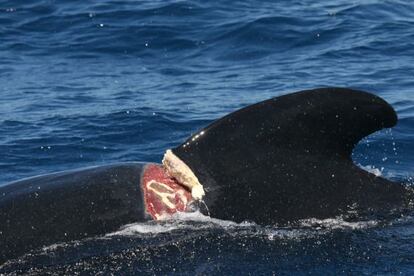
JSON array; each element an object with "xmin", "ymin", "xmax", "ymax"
[{"xmin": 141, "ymin": 164, "xmax": 192, "ymax": 220}]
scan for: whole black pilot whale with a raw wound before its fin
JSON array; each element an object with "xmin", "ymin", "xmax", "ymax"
[{"xmin": 0, "ymin": 88, "xmax": 412, "ymax": 263}]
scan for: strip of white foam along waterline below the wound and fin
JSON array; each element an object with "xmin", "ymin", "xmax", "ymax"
[{"xmin": 106, "ymin": 212, "xmax": 379, "ymax": 245}]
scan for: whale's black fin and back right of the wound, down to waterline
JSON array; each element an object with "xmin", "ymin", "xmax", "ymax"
[{"xmin": 173, "ymin": 88, "xmax": 404, "ymax": 223}]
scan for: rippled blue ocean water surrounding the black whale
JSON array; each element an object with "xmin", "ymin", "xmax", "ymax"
[{"xmin": 0, "ymin": 0, "xmax": 414, "ymax": 275}]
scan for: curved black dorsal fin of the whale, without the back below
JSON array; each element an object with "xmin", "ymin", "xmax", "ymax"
[{"xmin": 173, "ymin": 88, "xmax": 404, "ymax": 224}]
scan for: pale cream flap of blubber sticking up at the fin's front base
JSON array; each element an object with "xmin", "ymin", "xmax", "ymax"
[{"xmin": 162, "ymin": 150, "xmax": 205, "ymax": 200}]
